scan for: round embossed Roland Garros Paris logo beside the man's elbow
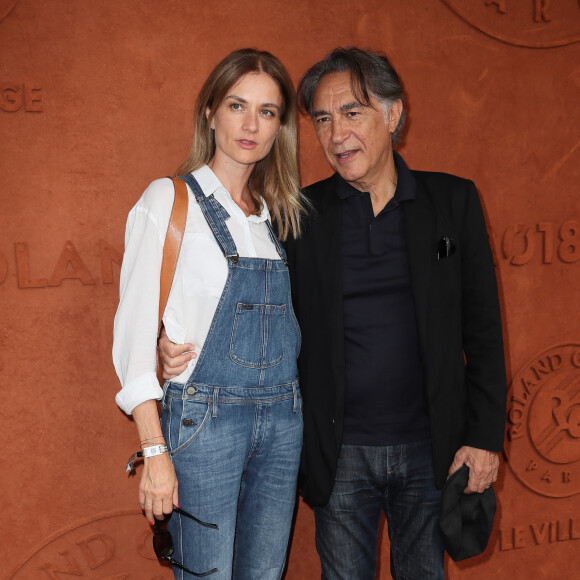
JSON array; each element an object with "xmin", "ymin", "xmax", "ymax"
[{"xmin": 506, "ymin": 344, "xmax": 580, "ymax": 497}]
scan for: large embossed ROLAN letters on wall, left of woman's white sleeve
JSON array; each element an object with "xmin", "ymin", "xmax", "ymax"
[{"xmin": 0, "ymin": 240, "xmax": 123, "ymax": 289}]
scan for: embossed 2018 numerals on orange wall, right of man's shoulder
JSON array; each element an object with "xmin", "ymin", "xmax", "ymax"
[{"xmin": 502, "ymin": 220, "xmax": 580, "ymax": 266}]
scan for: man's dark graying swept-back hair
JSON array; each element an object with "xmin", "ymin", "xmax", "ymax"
[{"xmin": 297, "ymin": 46, "xmax": 406, "ymax": 145}]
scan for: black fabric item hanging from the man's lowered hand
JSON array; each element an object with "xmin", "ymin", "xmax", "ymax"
[{"xmin": 439, "ymin": 465, "xmax": 496, "ymax": 562}]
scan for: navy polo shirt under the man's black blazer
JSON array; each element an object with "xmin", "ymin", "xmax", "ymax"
[{"xmin": 336, "ymin": 152, "xmax": 429, "ymax": 445}]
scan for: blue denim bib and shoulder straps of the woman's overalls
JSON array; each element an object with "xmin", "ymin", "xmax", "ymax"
[{"xmin": 176, "ymin": 175, "xmax": 300, "ymax": 396}]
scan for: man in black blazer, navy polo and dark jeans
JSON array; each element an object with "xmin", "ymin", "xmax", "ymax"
[{"xmin": 161, "ymin": 48, "xmax": 506, "ymax": 580}]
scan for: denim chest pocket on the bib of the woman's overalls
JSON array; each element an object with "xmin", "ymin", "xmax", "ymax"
[{"xmin": 230, "ymin": 302, "xmax": 286, "ymax": 369}]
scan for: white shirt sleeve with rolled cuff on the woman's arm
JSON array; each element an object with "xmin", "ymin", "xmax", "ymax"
[{"xmin": 113, "ymin": 179, "xmax": 174, "ymax": 414}]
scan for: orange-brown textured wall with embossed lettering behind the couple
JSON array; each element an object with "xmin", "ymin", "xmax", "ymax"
[{"xmin": 0, "ymin": 0, "xmax": 580, "ymax": 580}]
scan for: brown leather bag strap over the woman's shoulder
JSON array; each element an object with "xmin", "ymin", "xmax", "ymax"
[{"xmin": 157, "ymin": 177, "xmax": 188, "ymax": 333}]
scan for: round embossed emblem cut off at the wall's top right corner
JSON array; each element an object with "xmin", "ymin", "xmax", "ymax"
[{"xmin": 441, "ymin": 0, "xmax": 580, "ymax": 48}]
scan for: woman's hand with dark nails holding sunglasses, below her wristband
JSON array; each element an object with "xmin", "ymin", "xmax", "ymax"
[{"xmin": 139, "ymin": 453, "xmax": 179, "ymax": 525}]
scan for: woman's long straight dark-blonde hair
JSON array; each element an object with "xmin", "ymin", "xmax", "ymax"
[{"xmin": 178, "ymin": 48, "xmax": 305, "ymax": 240}]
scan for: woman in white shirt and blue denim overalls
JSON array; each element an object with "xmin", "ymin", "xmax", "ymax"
[{"xmin": 113, "ymin": 49, "xmax": 302, "ymax": 579}]
